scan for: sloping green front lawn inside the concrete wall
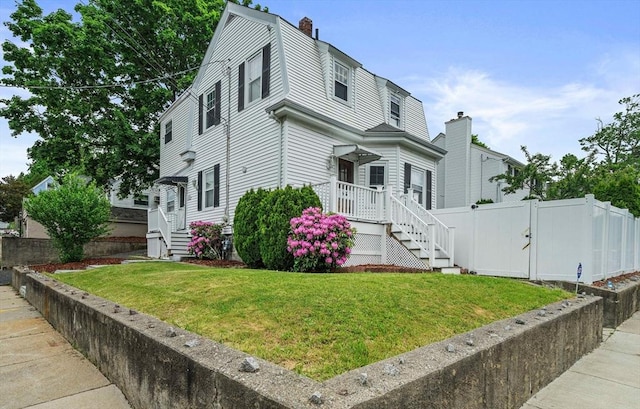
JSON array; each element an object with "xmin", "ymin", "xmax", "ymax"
[{"xmin": 55, "ymin": 263, "xmax": 570, "ymax": 381}]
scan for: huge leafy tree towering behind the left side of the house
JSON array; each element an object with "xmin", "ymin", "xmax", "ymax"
[{"xmin": 0, "ymin": 0, "xmax": 260, "ymax": 196}]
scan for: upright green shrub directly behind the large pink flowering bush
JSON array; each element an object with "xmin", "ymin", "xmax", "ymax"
[{"xmin": 258, "ymin": 186, "xmax": 321, "ymax": 271}]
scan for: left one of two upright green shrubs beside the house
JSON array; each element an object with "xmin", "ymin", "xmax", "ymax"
[{"xmin": 233, "ymin": 189, "xmax": 267, "ymax": 268}]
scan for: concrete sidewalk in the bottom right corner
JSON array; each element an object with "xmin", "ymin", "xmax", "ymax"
[{"xmin": 521, "ymin": 312, "xmax": 640, "ymax": 409}]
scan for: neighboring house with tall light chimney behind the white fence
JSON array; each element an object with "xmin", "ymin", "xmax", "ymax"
[{"xmin": 433, "ymin": 112, "xmax": 528, "ymax": 209}]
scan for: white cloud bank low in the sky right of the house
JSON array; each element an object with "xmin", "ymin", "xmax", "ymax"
[{"xmin": 410, "ymin": 53, "xmax": 640, "ymax": 164}]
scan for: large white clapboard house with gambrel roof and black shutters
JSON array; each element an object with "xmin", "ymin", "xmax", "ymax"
[{"xmin": 147, "ymin": 2, "xmax": 451, "ymax": 266}]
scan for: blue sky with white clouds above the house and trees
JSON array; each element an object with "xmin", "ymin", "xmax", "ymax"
[{"xmin": 0, "ymin": 0, "xmax": 640, "ymax": 177}]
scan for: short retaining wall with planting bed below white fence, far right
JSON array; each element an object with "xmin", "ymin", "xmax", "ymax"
[{"xmin": 556, "ymin": 281, "xmax": 640, "ymax": 328}]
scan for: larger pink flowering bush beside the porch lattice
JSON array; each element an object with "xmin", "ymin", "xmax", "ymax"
[{"xmin": 287, "ymin": 207, "xmax": 355, "ymax": 272}]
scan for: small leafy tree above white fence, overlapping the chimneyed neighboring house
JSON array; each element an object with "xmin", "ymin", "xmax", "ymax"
[{"xmin": 489, "ymin": 146, "xmax": 556, "ymax": 200}]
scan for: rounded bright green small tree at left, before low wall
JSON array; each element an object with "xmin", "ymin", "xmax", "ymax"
[{"xmin": 25, "ymin": 174, "xmax": 111, "ymax": 262}]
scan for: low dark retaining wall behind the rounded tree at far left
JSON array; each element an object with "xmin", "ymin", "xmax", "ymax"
[{"xmin": 0, "ymin": 237, "xmax": 147, "ymax": 268}]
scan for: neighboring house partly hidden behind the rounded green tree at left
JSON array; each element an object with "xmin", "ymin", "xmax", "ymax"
[{"xmin": 22, "ymin": 176, "xmax": 150, "ymax": 239}]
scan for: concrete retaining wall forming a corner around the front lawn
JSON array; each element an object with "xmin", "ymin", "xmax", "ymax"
[{"xmin": 14, "ymin": 269, "xmax": 602, "ymax": 409}]
